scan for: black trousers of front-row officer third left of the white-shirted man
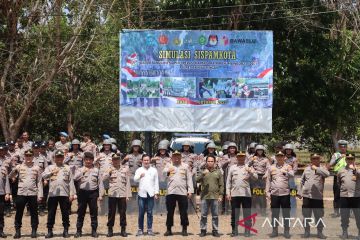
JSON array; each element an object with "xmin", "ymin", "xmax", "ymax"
[{"xmin": 47, "ymin": 196, "xmax": 70, "ymax": 229}]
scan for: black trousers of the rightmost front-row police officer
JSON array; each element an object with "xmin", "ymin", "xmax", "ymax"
[{"xmin": 340, "ymin": 197, "xmax": 360, "ymax": 231}]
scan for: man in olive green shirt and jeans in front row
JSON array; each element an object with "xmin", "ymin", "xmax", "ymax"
[{"xmin": 196, "ymin": 155, "xmax": 224, "ymax": 237}]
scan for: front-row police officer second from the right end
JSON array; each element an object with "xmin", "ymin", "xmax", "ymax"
[{"xmin": 298, "ymin": 153, "xmax": 330, "ymax": 239}]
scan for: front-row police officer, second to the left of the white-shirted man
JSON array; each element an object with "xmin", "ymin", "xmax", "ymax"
[{"xmin": 74, "ymin": 152, "xmax": 104, "ymax": 238}]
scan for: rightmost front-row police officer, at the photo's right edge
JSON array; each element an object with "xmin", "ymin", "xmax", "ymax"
[{"xmin": 337, "ymin": 153, "xmax": 360, "ymax": 239}]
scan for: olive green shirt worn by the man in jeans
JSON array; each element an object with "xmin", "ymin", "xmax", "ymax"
[{"xmin": 196, "ymin": 168, "xmax": 224, "ymax": 199}]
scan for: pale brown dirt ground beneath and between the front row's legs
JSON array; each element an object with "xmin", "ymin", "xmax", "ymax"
[{"xmin": 4, "ymin": 178, "xmax": 357, "ymax": 239}]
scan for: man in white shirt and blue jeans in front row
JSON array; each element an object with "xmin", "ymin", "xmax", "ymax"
[{"xmin": 134, "ymin": 154, "xmax": 159, "ymax": 236}]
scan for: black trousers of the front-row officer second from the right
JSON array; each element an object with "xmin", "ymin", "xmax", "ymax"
[{"xmin": 302, "ymin": 197, "xmax": 324, "ymax": 231}]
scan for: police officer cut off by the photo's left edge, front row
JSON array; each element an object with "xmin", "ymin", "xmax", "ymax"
[{"xmin": 0, "ymin": 149, "xmax": 10, "ymax": 238}]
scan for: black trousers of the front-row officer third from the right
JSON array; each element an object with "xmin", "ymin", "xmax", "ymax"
[{"xmin": 271, "ymin": 195, "xmax": 290, "ymax": 229}]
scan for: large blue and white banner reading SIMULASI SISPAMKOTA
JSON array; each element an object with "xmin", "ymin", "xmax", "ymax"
[{"xmin": 119, "ymin": 30, "xmax": 273, "ymax": 132}]
